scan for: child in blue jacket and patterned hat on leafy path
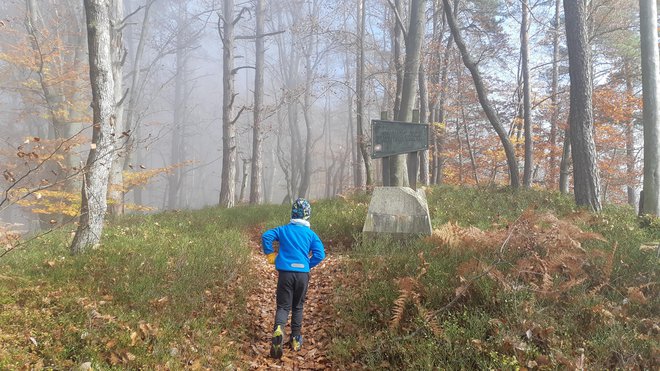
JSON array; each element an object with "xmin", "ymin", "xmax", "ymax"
[{"xmin": 261, "ymin": 198, "xmax": 325, "ymax": 358}]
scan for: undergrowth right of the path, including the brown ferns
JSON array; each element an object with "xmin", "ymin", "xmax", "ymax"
[{"xmin": 332, "ymin": 187, "xmax": 660, "ymax": 369}]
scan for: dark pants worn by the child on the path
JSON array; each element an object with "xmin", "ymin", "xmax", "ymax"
[{"xmin": 275, "ymin": 271, "xmax": 309, "ymax": 336}]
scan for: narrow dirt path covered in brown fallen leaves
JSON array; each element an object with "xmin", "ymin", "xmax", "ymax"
[{"xmin": 242, "ymin": 240, "xmax": 341, "ymax": 370}]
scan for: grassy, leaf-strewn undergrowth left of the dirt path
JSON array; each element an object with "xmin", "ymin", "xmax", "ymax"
[{"xmin": 0, "ymin": 206, "xmax": 282, "ymax": 369}]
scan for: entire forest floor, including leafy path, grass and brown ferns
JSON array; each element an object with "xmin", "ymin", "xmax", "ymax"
[{"xmin": 0, "ymin": 187, "xmax": 660, "ymax": 370}]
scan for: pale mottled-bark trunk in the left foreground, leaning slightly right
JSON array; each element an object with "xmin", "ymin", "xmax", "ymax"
[{"xmin": 71, "ymin": 0, "xmax": 116, "ymax": 254}]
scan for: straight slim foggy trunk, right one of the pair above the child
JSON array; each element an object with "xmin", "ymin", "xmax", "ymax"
[{"xmin": 250, "ymin": 0, "xmax": 266, "ymax": 205}]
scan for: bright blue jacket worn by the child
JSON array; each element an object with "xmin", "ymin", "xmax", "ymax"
[{"xmin": 261, "ymin": 219, "xmax": 325, "ymax": 272}]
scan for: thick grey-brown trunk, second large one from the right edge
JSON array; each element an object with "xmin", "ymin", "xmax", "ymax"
[{"xmin": 564, "ymin": 0, "xmax": 601, "ymax": 211}]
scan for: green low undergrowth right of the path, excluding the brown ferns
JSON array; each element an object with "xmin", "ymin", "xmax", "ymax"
[{"xmin": 334, "ymin": 187, "xmax": 660, "ymax": 369}]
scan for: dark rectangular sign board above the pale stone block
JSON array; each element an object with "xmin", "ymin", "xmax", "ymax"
[{"xmin": 371, "ymin": 120, "xmax": 429, "ymax": 158}]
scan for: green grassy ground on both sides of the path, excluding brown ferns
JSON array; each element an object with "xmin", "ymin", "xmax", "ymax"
[{"xmin": 0, "ymin": 187, "xmax": 660, "ymax": 369}]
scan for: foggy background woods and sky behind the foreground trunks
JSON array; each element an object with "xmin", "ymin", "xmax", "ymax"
[{"xmin": 0, "ymin": 0, "xmax": 643, "ymax": 230}]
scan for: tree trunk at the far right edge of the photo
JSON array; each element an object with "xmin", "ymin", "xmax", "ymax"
[{"xmin": 639, "ymin": 0, "xmax": 660, "ymax": 215}]
